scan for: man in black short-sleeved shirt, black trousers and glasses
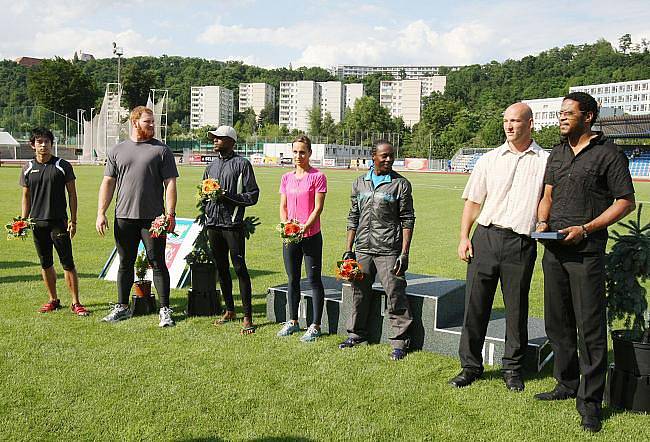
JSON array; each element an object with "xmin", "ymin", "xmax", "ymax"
[{"xmin": 535, "ymin": 92, "xmax": 635, "ymax": 432}]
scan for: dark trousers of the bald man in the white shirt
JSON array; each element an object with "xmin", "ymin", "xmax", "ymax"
[{"xmin": 458, "ymin": 224, "xmax": 537, "ymax": 371}]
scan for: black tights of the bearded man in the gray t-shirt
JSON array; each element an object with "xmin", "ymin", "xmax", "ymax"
[{"xmin": 113, "ymin": 218, "xmax": 169, "ymax": 307}]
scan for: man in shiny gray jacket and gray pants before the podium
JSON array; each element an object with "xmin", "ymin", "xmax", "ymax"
[{"xmin": 339, "ymin": 141, "xmax": 415, "ymax": 360}]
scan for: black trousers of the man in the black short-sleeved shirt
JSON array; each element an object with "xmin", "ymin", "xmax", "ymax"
[{"xmin": 542, "ymin": 247, "xmax": 607, "ymax": 415}]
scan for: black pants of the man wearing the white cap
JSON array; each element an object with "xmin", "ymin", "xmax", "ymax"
[{"xmin": 207, "ymin": 226, "xmax": 253, "ymax": 318}]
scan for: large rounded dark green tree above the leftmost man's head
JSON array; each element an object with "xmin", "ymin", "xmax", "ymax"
[{"xmin": 27, "ymin": 57, "xmax": 95, "ymax": 116}]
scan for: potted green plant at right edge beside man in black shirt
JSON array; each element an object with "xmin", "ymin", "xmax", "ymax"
[{"xmin": 605, "ymin": 204, "xmax": 650, "ymax": 411}]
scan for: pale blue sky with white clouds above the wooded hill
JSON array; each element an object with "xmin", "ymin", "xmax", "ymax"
[{"xmin": 0, "ymin": 0, "xmax": 650, "ymax": 67}]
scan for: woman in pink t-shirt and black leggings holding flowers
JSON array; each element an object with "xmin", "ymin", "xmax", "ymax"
[{"xmin": 278, "ymin": 135, "xmax": 327, "ymax": 342}]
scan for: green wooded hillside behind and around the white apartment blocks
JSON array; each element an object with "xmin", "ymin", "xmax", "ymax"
[{"xmin": 0, "ymin": 34, "xmax": 650, "ymax": 158}]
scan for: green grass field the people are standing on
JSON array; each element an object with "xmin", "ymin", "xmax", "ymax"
[{"xmin": 0, "ymin": 166, "xmax": 650, "ymax": 441}]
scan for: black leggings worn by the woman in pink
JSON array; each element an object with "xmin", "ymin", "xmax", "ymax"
[{"xmin": 282, "ymin": 232, "xmax": 325, "ymax": 325}]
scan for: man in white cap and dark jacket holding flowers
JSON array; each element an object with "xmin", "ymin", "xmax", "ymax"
[{"xmin": 203, "ymin": 126, "xmax": 260, "ymax": 334}]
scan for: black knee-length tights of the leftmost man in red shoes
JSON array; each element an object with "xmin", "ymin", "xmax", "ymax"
[{"xmin": 34, "ymin": 219, "xmax": 74, "ymax": 270}]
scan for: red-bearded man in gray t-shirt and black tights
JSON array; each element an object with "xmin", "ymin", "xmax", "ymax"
[{"xmin": 95, "ymin": 106, "xmax": 178, "ymax": 327}]
